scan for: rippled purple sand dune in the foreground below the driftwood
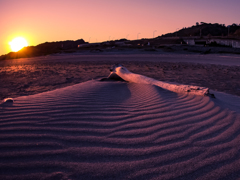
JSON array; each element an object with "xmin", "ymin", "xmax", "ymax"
[{"xmin": 0, "ymin": 81, "xmax": 240, "ymax": 179}]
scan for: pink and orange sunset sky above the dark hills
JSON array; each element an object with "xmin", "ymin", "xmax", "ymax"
[{"xmin": 0, "ymin": 0, "xmax": 240, "ymax": 55}]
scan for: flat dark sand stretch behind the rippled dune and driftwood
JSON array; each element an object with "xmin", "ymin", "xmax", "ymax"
[{"xmin": 0, "ymin": 54, "xmax": 240, "ymax": 100}]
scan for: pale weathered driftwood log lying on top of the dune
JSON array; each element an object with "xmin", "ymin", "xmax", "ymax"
[{"xmin": 108, "ymin": 64, "xmax": 214, "ymax": 97}]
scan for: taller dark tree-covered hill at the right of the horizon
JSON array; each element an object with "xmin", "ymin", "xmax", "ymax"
[{"xmin": 162, "ymin": 22, "xmax": 240, "ymax": 37}]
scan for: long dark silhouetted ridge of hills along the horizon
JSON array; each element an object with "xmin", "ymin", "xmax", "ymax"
[{"xmin": 0, "ymin": 22, "xmax": 240, "ymax": 60}]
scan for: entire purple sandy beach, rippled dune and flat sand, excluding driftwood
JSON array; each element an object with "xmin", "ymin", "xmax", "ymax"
[{"xmin": 0, "ymin": 53, "xmax": 240, "ymax": 180}]
